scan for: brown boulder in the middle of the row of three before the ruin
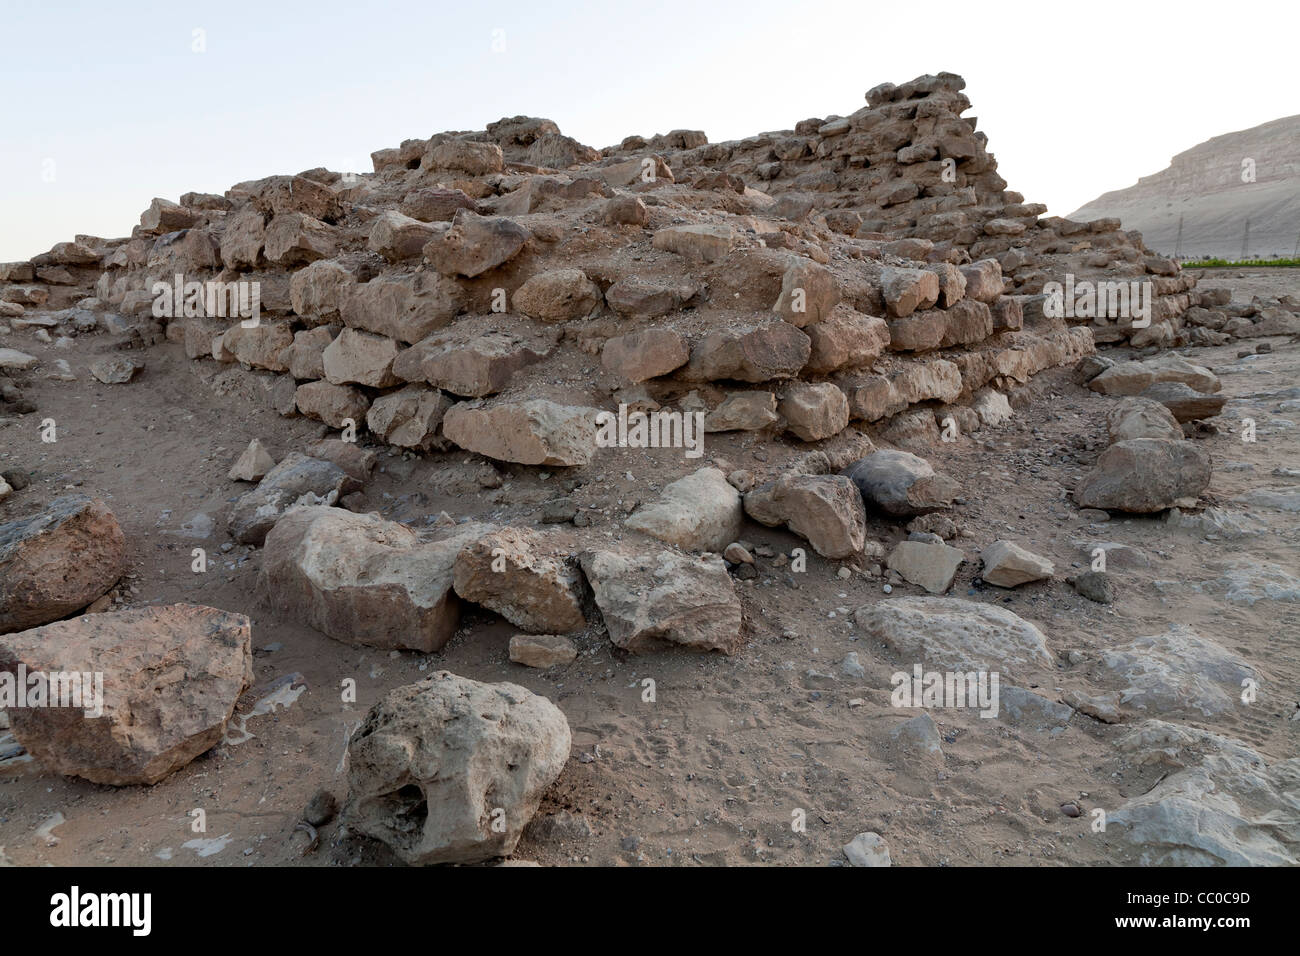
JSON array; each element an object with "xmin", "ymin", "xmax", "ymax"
[{"xmin": 454, "ymin": 528, "xmax": 586, "ymax": 635}]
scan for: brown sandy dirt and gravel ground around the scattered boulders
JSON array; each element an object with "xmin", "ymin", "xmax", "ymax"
[{"xmin": 0, "ymin": 271, "xmax": 1300, "ymax": 866}]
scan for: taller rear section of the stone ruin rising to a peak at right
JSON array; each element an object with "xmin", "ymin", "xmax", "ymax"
[{"xmin": 605, "ymin": 73, "xmax": 1214, "ymax": 346}]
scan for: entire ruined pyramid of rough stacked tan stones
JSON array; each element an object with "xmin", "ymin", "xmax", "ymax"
[{"xmin": 0, "ymin": 73, "xmax": 1237, "ymax": 455}]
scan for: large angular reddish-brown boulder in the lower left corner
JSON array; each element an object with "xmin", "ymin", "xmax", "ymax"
[{"xmin": 0, "ymin": 604, "xmax": 252, "ymax": 786}]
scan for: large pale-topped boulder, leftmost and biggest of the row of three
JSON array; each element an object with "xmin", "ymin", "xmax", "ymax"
[{"xmin": 261, "ymin": 506, "xmax": 491, "ymax": 653}]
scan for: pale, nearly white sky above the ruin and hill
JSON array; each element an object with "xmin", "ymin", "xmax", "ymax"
[{"xmin": 0, "ymin": 0, "xmax": 1300, "ymax": 261}]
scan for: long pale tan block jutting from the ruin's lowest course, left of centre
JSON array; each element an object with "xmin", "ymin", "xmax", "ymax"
[{"xmin": 442, "ymin": 398, "xmax": 599, "ymax": 466}]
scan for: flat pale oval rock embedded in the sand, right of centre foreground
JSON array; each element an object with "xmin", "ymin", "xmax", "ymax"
[{"xmin": 853, "ymin": 597, "xmax": 1052, "ymax": 679}]
